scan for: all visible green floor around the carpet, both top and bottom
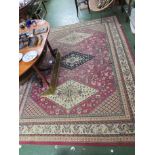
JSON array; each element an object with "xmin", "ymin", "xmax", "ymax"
[{"xmin": 19, "ymin": 0, "xmax": 135, "ymax": 155}]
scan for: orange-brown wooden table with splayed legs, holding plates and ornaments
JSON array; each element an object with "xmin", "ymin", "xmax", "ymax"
[{"xmin": 19, "ymin": 20, "xmax": 55, "ymax": 86}]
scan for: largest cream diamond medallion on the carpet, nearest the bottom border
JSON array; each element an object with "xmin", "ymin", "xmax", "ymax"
[{"xmin": 44, "ymin": 80, "xmax": 97, "ymax": 111}]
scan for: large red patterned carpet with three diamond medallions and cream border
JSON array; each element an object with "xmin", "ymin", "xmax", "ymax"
[{"xmin": 20, "ymin": 17, "xmax": 135, "ymax": 146}]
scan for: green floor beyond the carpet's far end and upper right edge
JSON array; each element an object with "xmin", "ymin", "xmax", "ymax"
[{"xmin": 46, "ymin": 0, "xmax": 135, "ymax": 55}]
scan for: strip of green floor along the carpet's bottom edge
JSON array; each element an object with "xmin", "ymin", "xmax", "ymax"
[{"xmin": 19, "ymin": 145, "xmax": 135, "ymax": 155}]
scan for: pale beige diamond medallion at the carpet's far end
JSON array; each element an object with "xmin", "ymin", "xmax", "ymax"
[{"xmin": 58, "ymin": 32, "xmax": 92, "ymax": 45}]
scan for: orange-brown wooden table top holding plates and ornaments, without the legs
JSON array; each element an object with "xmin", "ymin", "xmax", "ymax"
[{"xmin": 19, "ymin": 20, "xmax": 50, "ymax": 76}]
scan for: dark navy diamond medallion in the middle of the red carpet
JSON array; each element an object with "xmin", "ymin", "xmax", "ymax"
[{"xmin": 61, "ymin": 51, "xmax": 93, "ymax": 70}]
